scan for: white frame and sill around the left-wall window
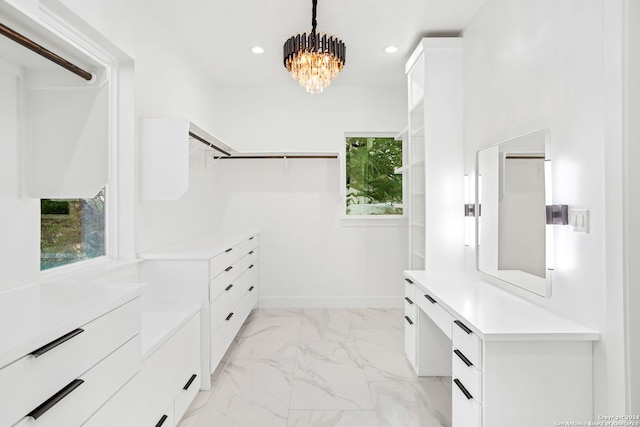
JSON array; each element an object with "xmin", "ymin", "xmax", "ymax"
[{"xmin": 36, "ymin": 3, "xmax": 136, "ymax": 281}]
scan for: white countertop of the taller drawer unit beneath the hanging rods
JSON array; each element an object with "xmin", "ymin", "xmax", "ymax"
[{"xmin": 138, "ymin": 230, "xmax": 258, "ymax": 259}]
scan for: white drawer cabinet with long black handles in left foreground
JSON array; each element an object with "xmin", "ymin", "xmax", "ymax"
[{"xmin": 0, "ymin": 285, "xmax": 140, "ymax": 427}]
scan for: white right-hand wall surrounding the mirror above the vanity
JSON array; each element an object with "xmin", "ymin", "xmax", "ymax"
[{"xmin": 464, "ymin": 0, "xmax": 625, "ymax": 415}]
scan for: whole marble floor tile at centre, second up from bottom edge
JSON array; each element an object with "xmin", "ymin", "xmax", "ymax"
[{"xmin": 290, "ymin": 342, "xmax": 373, "ymax": 410}]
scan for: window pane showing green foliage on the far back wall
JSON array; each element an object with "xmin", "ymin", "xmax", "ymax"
[{"xmin": 345, "ymin": 136, "xmax": 402, "ymax": 215}]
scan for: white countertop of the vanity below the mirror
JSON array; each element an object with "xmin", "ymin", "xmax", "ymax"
[{"xmin": 404, "ymin": 270, "xmax": 600, "ymax": 341}]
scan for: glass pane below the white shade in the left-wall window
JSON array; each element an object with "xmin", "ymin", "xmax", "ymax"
[{"xmin": 40, "ymin": 188, "xmax": 106, "ymax": 270}]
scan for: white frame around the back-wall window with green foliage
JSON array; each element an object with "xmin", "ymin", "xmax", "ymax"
[{"xmin": 340, "ymin": 132, "xmax": 409, "ymax": 227}]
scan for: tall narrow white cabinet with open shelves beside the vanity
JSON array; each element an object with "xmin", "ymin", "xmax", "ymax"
[{"xmin": 405, "ymin": 37, "xmax": 464, "ymax": 270}]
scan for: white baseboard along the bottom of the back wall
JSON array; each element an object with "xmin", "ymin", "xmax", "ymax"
[{"xmin": 258, "ymin": 296, "xmax": 403, "ymax": 308}]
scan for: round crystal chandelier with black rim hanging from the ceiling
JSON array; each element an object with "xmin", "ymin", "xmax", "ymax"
[{"xmin": 283, "ymin": 0, "xmax": 347, "ymax": 93}]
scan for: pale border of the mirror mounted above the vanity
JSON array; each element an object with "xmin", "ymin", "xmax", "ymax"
[{"xmin": 475, "ymin": 129, "xmax": 554, "ymax": 298}]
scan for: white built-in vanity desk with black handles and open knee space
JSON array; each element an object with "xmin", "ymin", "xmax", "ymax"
[{"xmin": 404, "ymin": 271, "xmax": 599, "ymax": 427}]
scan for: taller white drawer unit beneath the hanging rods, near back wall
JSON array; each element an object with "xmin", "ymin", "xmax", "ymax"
[{"xmin": 140, "ymin": 231, "xmax": 259, "ymax": 389}]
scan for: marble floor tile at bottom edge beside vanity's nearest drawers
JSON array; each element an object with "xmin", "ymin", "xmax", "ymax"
[{"xmin": 369, "ymin": 377, "xmax": 451, "ymax": 427}]
